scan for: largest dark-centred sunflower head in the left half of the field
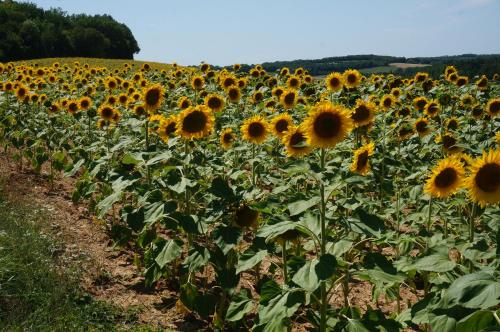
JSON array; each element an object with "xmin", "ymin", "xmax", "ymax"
[{"xmin": 176, "ymin": 105, "xmax": 215, "ymax": 139}]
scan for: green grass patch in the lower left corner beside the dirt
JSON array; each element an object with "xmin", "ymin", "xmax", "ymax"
[{"xmin": 0, "ymin": 180, "xmax": 149, "ymax": 331}]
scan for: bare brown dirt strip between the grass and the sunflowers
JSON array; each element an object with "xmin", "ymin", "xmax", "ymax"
[{"xmin": 0, "ymin": 154, "xmax": 200, "ymax": 331}]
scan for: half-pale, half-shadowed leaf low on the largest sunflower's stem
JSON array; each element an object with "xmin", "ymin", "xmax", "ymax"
[{"xmin": 292, "ymin": 254, "xmax": 337, "ymax": 293}]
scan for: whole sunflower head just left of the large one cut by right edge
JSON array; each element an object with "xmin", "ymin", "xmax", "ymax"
[{"xmin": 424, "ymin": 157, "xmax": 465, "ymax": 198}]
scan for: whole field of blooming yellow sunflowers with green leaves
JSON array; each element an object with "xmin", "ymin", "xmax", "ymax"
[{"xmin": 0, "ymin": 59, "xmax": 500, "ymax": 331}]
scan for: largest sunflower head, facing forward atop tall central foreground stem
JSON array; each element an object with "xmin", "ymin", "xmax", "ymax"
[{"xmin": 304, "ymin": 102, "xmax": 353, "ymax": 148}]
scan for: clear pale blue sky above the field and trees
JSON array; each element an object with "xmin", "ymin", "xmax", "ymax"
[{"xmin": 20, "ymin": 0, "xmax": 500, "ymax": 65}]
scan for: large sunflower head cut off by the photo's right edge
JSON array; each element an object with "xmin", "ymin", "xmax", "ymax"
[{"xmin": 465, "ymin": 150, "xmax": 500, "ymax": 207}]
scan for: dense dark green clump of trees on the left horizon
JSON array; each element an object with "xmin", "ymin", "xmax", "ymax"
[{"xmin": 0, "ymin": 0, "xmax": 140, "ymax": 62}]
